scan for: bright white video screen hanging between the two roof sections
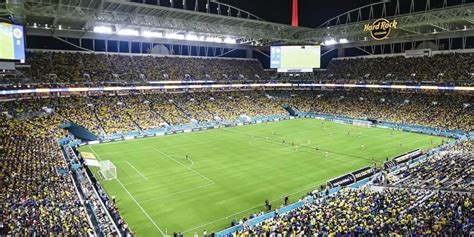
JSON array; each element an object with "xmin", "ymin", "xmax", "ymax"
[{"xmin": 270, "ymin": 45, "xmax": 321, "ymax": 72}]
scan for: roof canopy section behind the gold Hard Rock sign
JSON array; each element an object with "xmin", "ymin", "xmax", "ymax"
[{"xmin": 298, "ymin": 3, "xmax": 474, "ymax": 47}]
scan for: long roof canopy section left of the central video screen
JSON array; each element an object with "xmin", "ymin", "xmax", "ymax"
[{"xmin": 0, "ymin": 0, "xmax": 313, "ymax": 45}]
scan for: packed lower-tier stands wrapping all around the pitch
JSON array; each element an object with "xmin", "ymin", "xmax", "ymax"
[{"xmin": 0, "ymin": 84, "xmax": 473, "ymax": 235}]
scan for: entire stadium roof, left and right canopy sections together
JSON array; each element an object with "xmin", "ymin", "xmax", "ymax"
[{"xmin": 0, "ymin": 0, "xmax": 474, "ymax": 47}]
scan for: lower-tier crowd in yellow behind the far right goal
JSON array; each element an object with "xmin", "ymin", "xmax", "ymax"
[{"xmin": 287, "ymin": 91, "xmax": 474, "ymax": 131}]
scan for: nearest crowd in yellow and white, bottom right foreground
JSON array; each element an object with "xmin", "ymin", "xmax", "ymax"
[{"xmin": 241, "ymin": 141, "xmax": 474, "ymax": 236}]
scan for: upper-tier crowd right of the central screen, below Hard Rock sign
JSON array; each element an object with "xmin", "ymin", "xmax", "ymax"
[{"xmin": 326, "ymin": 53, "xmax": 474, "ymax": 82}]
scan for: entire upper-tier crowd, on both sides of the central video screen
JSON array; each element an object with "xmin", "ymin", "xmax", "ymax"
[{"xmin": 11, "ymin": 51, "xmax": 474, "ymax": 84}]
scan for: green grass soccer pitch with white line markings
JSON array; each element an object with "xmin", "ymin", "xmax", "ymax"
[{"xmin": 80, "ymin": 119, "xmax": 443, "ymax": 236}]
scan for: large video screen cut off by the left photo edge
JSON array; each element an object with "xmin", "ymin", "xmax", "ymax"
[{"xmin": 0, "ymin": 22, "xmax": 25, "ymax": 61}]
